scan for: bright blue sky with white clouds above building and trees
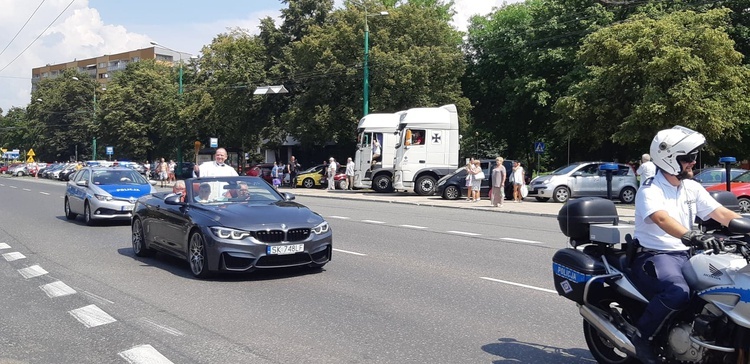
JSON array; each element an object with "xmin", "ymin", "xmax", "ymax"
[{"xmin": 0, "ymin": 0, "xmax": 513, "ymax": 113}]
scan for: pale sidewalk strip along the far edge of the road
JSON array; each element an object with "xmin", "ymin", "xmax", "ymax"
[{"xmin": 279, "ymin": 188, "xmax": 635, "ymax": 224}]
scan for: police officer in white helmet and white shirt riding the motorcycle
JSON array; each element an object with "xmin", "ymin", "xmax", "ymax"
[{"xmin": 632, "ymin": 126, "xmax": 741, "ymax": 363}]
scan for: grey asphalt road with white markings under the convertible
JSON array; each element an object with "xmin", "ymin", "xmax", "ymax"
[{"xmin": 0, "ymin": 178, "xmax": 593, "ymax": 363}]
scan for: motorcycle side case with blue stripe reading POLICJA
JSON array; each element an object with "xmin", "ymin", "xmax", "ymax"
[{"xmin": 552, "ymin": 248, "xmax": 606, "ymax": 304}]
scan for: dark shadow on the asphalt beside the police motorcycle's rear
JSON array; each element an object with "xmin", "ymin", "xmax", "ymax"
[{"xmin": 482, "ymin": 338, "xmax": 596, "ymax": 364}]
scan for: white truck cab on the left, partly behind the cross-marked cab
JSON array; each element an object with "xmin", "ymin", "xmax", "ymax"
[{"xmin": 354, "ymin": 113, "xmax": 400, "ymax": 192}]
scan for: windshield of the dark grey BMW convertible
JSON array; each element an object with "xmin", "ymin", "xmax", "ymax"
[{"xmin": 188, "ymin": 177, "xmax": 283, "ymax": 205}]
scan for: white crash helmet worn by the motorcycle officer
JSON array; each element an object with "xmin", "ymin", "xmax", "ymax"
[{"xmin": 651, "ymin": 125, "xmax": 706, "ymax": 176}]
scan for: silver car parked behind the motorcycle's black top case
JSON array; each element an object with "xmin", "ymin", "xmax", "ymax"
[{"xmin": 529, "ymin": 162, "xmax": 638, "ymax": 203}]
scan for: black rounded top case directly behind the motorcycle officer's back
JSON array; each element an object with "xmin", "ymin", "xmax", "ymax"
[{"xmin": 557, "ymin": 197, "xmax": 619, "ymax": 243}]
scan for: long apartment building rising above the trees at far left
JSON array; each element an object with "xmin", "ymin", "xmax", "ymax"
[{"xmin": 31, "ymin": 46, "xmax": 192, "ymax": 91}]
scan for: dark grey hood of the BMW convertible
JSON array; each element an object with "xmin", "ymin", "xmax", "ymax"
[{"xmin": 196, "ymin": 201, "xmax": 324, "ymax": 230}]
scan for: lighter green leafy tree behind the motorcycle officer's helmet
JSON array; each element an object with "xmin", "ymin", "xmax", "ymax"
[{"xmin": 555, "ymin": 9, "xmax": 750, "ymax": 156}]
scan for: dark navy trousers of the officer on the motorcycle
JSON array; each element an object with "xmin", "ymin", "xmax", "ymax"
[{"xmin": 632, "ymin": 251, "xmax": 690, "ymax": 339}]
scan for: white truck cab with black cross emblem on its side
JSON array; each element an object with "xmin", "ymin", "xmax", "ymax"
[{"xmin": 393, "ymin": 104, "xmax": 459, "ymax": 196}]
